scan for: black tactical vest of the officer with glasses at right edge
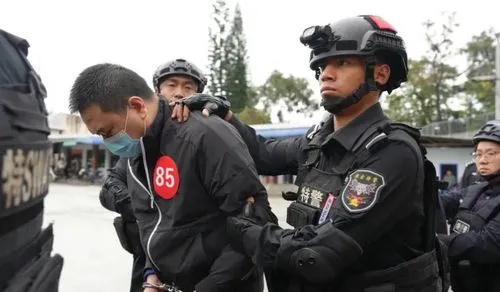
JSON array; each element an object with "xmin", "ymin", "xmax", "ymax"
[{"xmin": 450, "ymin": 182, "xmax": 500, "ymax": 292}]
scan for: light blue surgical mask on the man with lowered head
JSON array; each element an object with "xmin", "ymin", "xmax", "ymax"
[{"xmin": 104, "ymin": 110, "xmax": 146, "ymax": 158}]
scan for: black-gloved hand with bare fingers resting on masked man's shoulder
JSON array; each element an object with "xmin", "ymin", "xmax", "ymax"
[{"xmin": 169, "ymin": 93, "xmax": 232, "ymax": 122}]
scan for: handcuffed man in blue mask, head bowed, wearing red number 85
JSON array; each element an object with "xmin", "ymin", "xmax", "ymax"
[{"xmin": 70, "ymin": 64, "xmax": 277, "ymax": 292}]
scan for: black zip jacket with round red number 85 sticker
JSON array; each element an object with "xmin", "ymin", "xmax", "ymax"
[{"xmin": 127, "ymin": 99, "xmax": 277, "ymax": 291}]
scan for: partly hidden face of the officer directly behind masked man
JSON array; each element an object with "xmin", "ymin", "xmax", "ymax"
[{"xmin": 159, "ymin": 75, "xmax": 198, "ymax": 102}]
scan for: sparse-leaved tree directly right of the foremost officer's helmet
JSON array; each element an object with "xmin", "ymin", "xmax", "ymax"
[{"xmin": 388, "ymin": 13, "xmax": 464, "ymax": 126}]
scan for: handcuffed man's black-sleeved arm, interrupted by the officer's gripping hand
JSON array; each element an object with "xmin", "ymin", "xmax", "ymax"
[{"xmin": 196, "ymin": 117, "xmax": 274, "ymax": 291}]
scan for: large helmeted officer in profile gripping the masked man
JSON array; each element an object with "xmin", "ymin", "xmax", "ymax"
[{"xmin": 174, "ymin": 16, "xmax": 441, "ymax": 292}]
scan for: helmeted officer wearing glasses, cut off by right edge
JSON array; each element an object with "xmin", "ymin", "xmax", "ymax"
[{"xmin": 440, "ymin": 120, "xmax": 500, "ymax": 292}]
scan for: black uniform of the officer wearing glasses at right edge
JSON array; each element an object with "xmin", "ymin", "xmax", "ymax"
[{"xmin": 441, "ymin": 182, "xmax": 500, "ymax": 292}]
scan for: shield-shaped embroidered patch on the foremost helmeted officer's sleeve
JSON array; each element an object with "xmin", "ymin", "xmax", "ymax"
[{"xmin": 342, "ymin": 169, "xmax": 385, "ymax": 213}]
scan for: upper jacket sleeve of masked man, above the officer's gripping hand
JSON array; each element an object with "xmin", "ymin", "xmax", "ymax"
[{"xmin": 196, "ymin": 117, "xmax": 266, "ymax": 214}]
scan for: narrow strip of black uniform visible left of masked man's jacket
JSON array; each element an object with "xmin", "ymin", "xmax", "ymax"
[{"xmin": 99, "ymin": 158, "xmax": 146, "ymax": 292}]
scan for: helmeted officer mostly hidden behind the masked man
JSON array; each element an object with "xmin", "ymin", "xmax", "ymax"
[{"xmin": 99, "ymin": 59, "xmax": 207, "ymax": 292}]
